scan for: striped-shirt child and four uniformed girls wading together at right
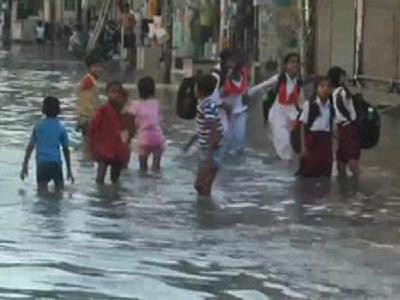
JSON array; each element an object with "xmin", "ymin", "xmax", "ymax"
[{"xmin": 195, "ymin": 50, "xmax": 361, "ymax": 196}]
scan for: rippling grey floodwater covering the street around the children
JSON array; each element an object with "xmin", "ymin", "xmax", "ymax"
[{"xmin": 0, "ymin": 45, "xmax": 400, "ymax": 300}]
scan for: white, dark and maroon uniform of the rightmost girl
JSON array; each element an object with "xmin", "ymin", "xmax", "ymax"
[{"xmin": 332, "ymin": 87, "xmax": 361, "ymax": 164}]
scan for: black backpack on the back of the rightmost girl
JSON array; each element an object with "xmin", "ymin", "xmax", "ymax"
[{"xmin": 353, "ymin": 94, "xmax": 381, "ymax": 149}]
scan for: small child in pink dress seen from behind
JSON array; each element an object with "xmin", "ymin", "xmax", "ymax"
[{"xmin": 130, "ymin": 77, "xmax": 165, "ymax": 174}]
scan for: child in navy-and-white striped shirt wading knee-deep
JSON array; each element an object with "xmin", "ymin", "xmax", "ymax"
[{"xmin": 195, "ymin": 74, "xmax": 223, "ymax": 197}]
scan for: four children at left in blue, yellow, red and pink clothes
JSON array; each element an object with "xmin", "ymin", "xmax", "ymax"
[{"xmin": 21, "ymin": 53, "xmax": 165, "ymax": 192}]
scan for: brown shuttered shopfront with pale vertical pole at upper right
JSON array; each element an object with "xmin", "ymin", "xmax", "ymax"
[{"xmin": 311, "ymin": 0, "xmax": 400, "ymax": 83}]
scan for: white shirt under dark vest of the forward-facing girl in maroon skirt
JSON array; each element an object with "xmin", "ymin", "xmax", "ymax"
[{"xmin": 300, "ymin": 98, "xmax": 331, "ymax": 132}]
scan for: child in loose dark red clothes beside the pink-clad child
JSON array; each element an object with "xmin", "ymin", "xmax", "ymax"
[{"xmin": 88, "ymin": 82, "xmax": 131, "ymax": 185}]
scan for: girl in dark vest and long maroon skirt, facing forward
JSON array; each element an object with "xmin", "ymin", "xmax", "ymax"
[{"xmin": 297, "ymin": 78, "xmax": 334, "ymax": 178}]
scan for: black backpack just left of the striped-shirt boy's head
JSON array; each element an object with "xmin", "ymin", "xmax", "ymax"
[{"xmin": 176, "ymin": 76, "xmax": 197, "ymax": 120}]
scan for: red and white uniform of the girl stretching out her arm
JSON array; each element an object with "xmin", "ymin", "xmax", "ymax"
[{"xmin": 268, "ymin": 74, "xmax": 303, "ymax": 161}]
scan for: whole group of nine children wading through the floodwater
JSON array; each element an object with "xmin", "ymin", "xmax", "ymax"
[{"xmin": 21, "ymin": 50, "xmax": 361, "ymax": 197}]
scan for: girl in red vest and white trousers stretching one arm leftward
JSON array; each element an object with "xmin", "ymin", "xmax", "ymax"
[{"xmin": 247, "ymin": 53, "xmax": 304, "ymax": 161}]
